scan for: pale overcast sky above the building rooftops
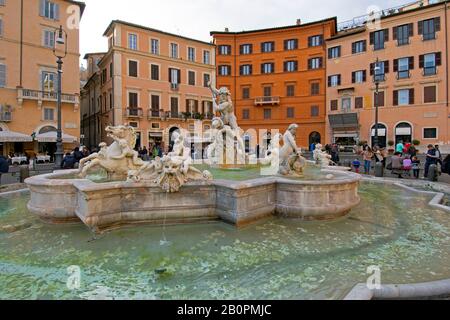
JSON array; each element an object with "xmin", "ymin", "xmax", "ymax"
[{"xmin": 81, "ymin": 0, "xmax": 406, "ymax": 66}]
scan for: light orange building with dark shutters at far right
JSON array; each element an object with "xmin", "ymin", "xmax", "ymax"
[{"xmin": 326, "ymin": 3, "xmax": 450, "ymax": 152}]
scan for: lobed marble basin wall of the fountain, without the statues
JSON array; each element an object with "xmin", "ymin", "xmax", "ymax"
[{"xmin": 25, "ymin": 170, "xmax": 361, "ymax": 232}]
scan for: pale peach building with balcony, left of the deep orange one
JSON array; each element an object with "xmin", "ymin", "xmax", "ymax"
[{"xmin": 82, "ymin": 20, "xmax": 215, "ymax": 151}]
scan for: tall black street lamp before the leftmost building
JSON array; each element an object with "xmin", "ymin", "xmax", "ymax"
[{"xmin": 53, "ymin": 26, "xmax": 67, "ymax": 169}]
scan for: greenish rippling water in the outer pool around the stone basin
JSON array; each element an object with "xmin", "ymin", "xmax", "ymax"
[{"xmin": 0, "ymin": 180, "xmax": 450, "ymax": 299}]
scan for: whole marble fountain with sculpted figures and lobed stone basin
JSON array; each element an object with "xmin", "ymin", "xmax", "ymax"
[{"xmin": 26, "ymin": 86, "xmax": 360, "ymax": 232}]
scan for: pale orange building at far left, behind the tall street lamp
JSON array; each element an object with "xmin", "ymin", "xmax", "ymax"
[{"xmin": 0, "ymin": 0, "xmax": 85, "ymax": 155}]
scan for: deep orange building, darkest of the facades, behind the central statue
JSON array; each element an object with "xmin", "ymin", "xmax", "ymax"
[{"xmin": 211, "ymin": 18, "xmax": 336, "ymax": 148}]
